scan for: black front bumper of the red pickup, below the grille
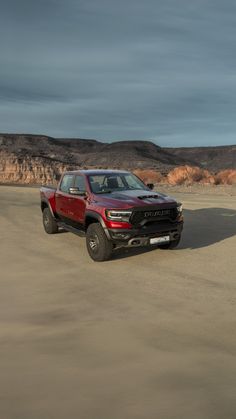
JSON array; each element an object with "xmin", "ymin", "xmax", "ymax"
[{"xmin": 107, "ymin": 221, "xmax": 183, "ymax": 247}]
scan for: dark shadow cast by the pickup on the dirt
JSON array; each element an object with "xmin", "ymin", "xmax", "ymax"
[{"xmin": 113, "ymin": 208, "xmax": 236, "ymax": 259}]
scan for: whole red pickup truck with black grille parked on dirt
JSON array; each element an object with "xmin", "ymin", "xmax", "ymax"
[{"xmin": 40, "ymin": 170, "xmax": 183, "ymax": 261}]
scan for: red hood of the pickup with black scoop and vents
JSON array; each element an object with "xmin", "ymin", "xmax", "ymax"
[{"xmin": 94, "ymin": 189, "xmax": 176, "ymax": 208}]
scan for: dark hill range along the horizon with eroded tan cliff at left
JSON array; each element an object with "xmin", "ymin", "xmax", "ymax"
[{"xmin": 0, "ymin": 134, "xmax": 236, "ymax": 183}]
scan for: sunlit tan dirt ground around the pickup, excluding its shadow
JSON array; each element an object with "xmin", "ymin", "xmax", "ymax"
[{"xmin": 0, "ymin": 186, "xmax": 236, "ymax": 419}]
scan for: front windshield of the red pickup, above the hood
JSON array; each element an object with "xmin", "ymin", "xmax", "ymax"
[{"xmin": 89, "ymin": 173, "xmax": 149, "ymax": 194}]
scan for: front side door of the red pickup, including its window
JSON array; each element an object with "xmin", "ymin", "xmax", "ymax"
[{"xmin": 70, "ymin": 175, "xmax": 87, "ymax": 224}]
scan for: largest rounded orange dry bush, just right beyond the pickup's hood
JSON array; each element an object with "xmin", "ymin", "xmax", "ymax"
[{"xmin": 167, "ymin": 166, "xmax": 215, "ymax": 185}]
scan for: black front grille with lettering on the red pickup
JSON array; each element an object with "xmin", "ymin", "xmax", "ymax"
[{"xmin": 130, "ymin": 208, "xmax": 178, "ymax": 225}]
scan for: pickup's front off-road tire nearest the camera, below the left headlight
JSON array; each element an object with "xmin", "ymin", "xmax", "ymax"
[{"xmin": 86, "ymin": 223, "xmax": 113, "ymax": 262}]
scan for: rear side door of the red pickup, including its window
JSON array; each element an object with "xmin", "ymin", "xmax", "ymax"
[{"xmin": 55, "ymin": 174, "xmax": 74, "ymax": 221}]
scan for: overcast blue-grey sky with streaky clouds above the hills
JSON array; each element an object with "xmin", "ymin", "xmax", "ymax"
[{"xmin": 0, "ymin": 0, "xmax": 236, "ymax": 146}]
